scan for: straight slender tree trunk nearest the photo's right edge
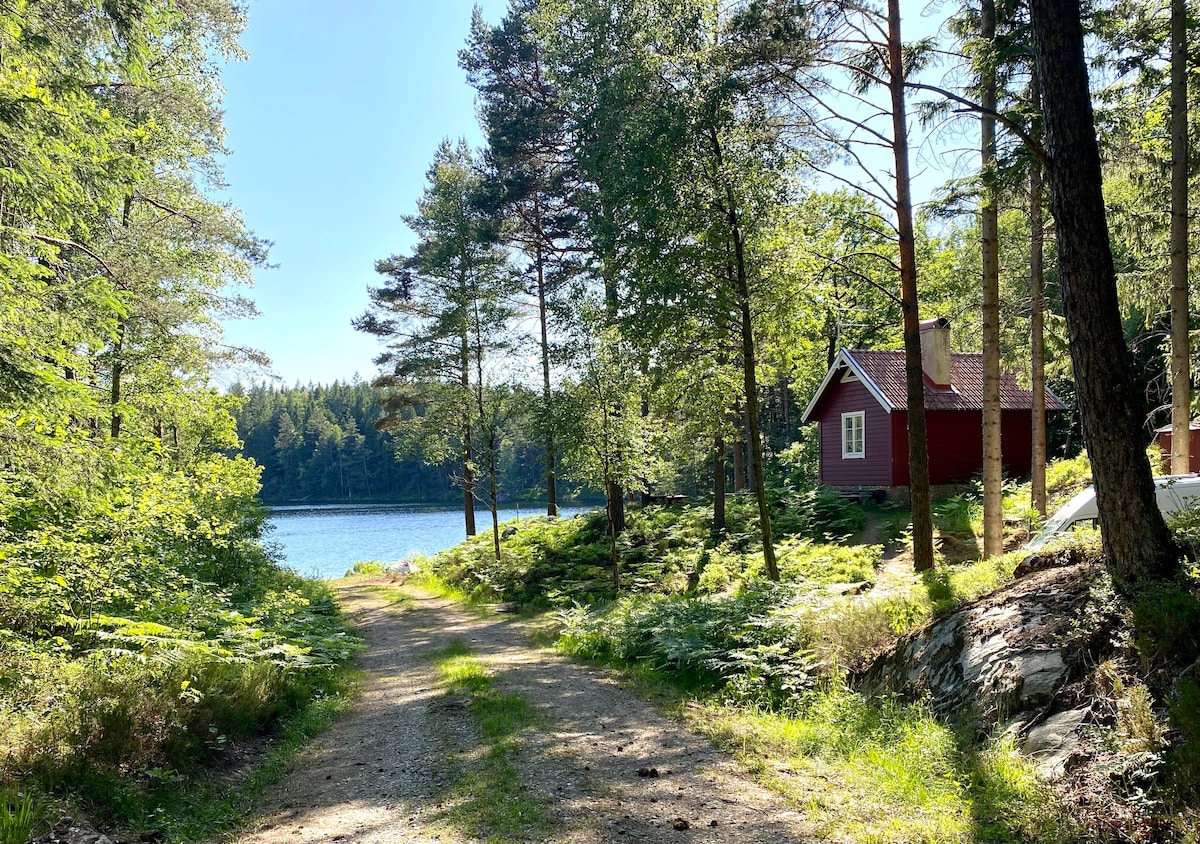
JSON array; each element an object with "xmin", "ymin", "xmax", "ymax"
[{"xmin": 1171, "ymin": 0, "xmax": 1192, "ymax": 474}]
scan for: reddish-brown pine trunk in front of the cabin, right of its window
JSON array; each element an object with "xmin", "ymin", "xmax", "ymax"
[{"xmin": 888, "ymin": 0, "xmax": 934, "ymax": 571}]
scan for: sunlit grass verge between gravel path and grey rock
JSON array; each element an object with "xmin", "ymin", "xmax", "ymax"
[{"xmin": 684, "ymin": 684, "xmax": 1075, "ymax": 844}]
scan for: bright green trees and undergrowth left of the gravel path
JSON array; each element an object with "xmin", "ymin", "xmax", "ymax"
[{"xmin": 0, "ymin": 0, "xmax": 355, "ymax": 843}]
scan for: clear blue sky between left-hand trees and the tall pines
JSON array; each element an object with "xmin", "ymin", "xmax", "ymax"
[{"xmin": 223, "ymin": 0, "xmax": 506, "ymax": 385}]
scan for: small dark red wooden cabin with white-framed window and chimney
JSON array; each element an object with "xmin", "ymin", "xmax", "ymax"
[{"xmin": 803, "ymin": 319, "xmax": 1067, "ymax": 492}]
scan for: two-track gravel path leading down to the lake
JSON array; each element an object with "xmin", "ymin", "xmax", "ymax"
[{"xmin": 231, "ymin": 585, "xmax": 814, "ymax": 844}]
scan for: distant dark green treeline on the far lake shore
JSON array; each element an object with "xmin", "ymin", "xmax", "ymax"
[{"xmin": 232, "ymin": 381, "xmax": 585, "ymax": 504}]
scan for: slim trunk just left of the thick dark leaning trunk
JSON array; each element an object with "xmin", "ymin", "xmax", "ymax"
[{"xmin": 1030, "ymin": 77, "xmax": 1046, "ymax": 517}]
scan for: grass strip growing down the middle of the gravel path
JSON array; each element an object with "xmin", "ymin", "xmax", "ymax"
[{"xmin": 434, "ymin": 640, "xmax": 554, "ymax": 842}]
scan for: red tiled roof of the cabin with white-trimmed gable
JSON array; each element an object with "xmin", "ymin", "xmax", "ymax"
[{"xmin": 804, "ymin": 349, "xmax": 1067, "ymax": 421}]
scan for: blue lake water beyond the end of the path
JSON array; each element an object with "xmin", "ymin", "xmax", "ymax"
[{"xmin": 268, "ymin": 504, "xmax": 592, "ymax": 577}]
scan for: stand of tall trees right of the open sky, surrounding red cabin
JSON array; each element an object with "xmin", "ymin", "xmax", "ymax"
[{"xmin": 350, "ymin": 0, "xmax": 1192, "ymax": 580}]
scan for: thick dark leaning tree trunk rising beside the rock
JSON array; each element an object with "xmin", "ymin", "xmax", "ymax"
[{"xmin": 1027, "ymin": 0, "xmax": 1178, "ymax": 588}]
